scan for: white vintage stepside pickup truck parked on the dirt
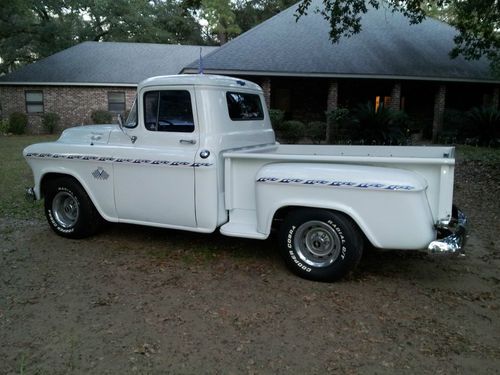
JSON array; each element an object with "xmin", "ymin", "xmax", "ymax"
[{"xmin": 24, "ymin": 75, "xmax": 467, "ymax": 281}]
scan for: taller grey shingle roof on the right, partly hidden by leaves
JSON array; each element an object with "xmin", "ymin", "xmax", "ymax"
[{"xmin": 184, "ymin": 0, "xmax": 498, "ymax": 81}]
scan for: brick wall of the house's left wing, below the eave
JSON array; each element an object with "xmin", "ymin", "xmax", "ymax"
[{"xmin": 0, "ymin": 86, "xmax": 136, "ymax": 134}]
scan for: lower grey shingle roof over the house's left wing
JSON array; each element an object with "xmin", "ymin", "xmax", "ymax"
[{"xmin": 0, "ymin": 42, "xmax": 218, "ymax": 85}]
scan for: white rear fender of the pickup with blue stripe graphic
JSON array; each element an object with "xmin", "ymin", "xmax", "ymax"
[{"xmin": 256, "ymin": 163, "xmax": 436, "ymax": 249}]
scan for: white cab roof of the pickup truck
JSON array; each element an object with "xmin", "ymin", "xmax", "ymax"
[{"xmin": 138, "ymin": 74, "xmax": 262, "ymax": 91}]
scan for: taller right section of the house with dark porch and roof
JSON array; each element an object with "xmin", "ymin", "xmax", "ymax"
[{"xmin": 183, "ymin": 0, "xmax": 500, "ymax": 141}]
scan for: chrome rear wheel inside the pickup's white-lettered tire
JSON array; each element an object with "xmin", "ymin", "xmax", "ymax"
[{"xmin": 294, "ymin": 221, "xmax": 342, "ymax": 268}]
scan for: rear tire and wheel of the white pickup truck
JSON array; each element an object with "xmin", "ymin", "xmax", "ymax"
[{"xmin": 280, "ymin": 209, "xmax": 363, "ymax": 281}]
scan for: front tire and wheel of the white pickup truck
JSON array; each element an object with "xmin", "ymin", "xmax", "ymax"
[{"xmin": 44, "ymin": 177, "xmax": 102, "ymax": 238}]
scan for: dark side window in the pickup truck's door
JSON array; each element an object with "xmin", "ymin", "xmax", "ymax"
[{"xmin": 144, "ymin": 90, "xmax": 194, "ymax": 133}]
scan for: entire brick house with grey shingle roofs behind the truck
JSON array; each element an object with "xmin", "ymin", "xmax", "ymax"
[{"xmin": 0, "ymin": 0, "xmax": 500, "ymax": 139}]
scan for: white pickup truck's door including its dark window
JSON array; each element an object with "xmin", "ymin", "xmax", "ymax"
[{"xmin": 114, "ymin": 86, "xmax": 199, "ymax": 227}]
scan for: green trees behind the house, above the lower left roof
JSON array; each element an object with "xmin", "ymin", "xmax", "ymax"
[{"xmin": 0, "ymin": 0, "xmax": 295, "ymax": 74}]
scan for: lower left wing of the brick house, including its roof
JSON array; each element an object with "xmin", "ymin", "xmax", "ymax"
[{"xmin": 0, "ymin": 42, "xmax": 217, "ymax": 134}]
